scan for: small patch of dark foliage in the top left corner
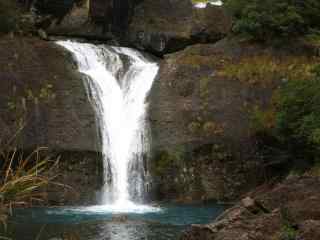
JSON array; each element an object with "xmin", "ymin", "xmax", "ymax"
[{"xmin": 0, "ymin": 0, "xmax": 20, "ymax": 34}]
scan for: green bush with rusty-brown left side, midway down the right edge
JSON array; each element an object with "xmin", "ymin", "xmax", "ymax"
[{"xmin": 251, "ymin": 62, "xmax": 320, "ymax": 172}]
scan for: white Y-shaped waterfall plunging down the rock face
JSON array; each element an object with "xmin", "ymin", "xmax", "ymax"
[{"xmin": 57, "ymin": 41, "xmax": 158, "ymax": 212}]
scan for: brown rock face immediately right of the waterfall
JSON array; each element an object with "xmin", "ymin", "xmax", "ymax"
[{"xmin": 150, "ymin": 41, "xmax": 277, "ymax": 201}]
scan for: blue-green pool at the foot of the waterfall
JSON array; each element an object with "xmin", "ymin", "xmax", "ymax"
[{"xmin": 7, "ymin": 204, "xmax": 225, "ymax": 240}]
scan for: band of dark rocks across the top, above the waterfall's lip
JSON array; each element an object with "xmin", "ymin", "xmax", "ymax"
[{"xmin": 36, "ymin": 0, "xmax": 231, "ymax": 52}]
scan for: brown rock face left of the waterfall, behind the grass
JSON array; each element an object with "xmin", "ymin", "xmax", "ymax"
[{"xmin": 0, "ymin": 37, "xmax": 101, "ymax": 203}]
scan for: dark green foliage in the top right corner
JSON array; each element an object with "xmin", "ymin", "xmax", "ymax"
[{"xmin": 225, "ymin": 0, "xmax": 320, "ymax": 41}]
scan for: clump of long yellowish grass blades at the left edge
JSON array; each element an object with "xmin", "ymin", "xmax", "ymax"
[{"xmin": 0, "ymin": 136, "xmax": 58, "ymax": 234}]
